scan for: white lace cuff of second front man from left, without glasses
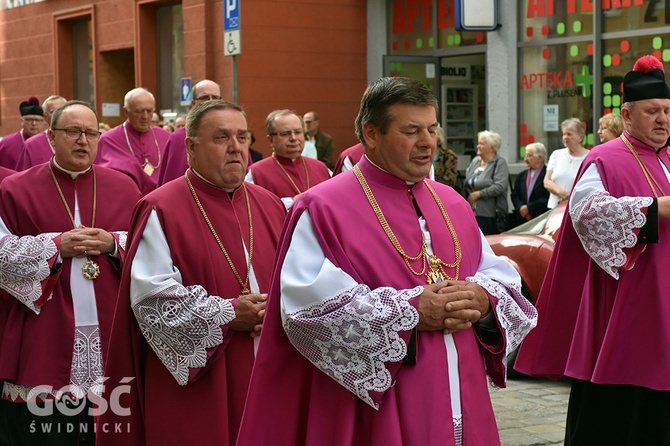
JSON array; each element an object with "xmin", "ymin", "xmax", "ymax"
[{"xmin": 132, "ymin": 282, "xmax": 235, "ymax": 385}]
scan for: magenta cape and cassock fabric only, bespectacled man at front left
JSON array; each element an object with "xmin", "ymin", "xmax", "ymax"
[{"xmin": 0, "ymin": 164, "xmax": 140, "ymax": 389}]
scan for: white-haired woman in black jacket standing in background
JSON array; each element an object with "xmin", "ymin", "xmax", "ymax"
[{"xmin": 512, "ymin": 142, "xmax": 549, "ymax": 225}]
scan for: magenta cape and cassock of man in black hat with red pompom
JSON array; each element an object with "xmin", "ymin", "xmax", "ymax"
[{"xmin": 515, "ymin": 135, "xmax": 670, "ymax": 391}]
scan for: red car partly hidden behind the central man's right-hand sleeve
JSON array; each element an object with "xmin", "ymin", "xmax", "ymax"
[{"xmin": 486, "ymin": 203, "xmax": 566, "ymax": 304}]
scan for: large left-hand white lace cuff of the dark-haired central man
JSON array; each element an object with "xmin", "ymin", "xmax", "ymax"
[{"xmin": 284, "ymin": 285, "xmax": 423, "ymax": 409}]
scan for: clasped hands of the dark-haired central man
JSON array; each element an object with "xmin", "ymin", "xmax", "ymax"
[{"xmin": 417, "ymin": 280, "xmax": 491, "ymax": 334}]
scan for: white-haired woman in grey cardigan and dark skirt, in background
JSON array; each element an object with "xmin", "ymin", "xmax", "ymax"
[{"xmin": 464, "ymin": 130, "xmax": 509, "ymax": 235}]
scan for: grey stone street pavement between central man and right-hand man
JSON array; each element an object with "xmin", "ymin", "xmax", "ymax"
[{"xmin": 491, "ymin": 377, "xmax": 570, "ymax": 446}]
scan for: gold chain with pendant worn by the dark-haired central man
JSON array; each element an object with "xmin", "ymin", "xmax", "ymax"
[{"xmin": 353, "ymin": 165, "xmax": 462, "ymax": 283}]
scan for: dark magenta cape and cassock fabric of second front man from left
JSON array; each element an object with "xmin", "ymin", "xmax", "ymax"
[{"xmin": 96, "ymin": 171, "xmax": 286, "ymax": 446}]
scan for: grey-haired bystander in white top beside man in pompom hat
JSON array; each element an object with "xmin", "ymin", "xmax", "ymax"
[{"xmin": 544, "ymin": 118, "xmax": 589, "ymax": 209}]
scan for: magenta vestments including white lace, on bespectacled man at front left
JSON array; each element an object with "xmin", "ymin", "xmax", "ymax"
[{"xmin": 0, "ymin": 161, "xmax": 140, "ymax": 440}]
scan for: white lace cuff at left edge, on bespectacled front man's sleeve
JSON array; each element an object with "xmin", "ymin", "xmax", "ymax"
[{"xmin": 0, "ymin": 233, "xmax": 58, "ymax": 314}]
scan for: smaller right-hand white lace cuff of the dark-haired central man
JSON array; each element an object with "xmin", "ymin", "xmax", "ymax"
[{"xmin": 466, "ymin": 273, "xmax": 537, "ymax": 367}]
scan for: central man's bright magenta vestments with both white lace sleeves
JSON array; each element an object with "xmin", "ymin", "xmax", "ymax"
[{"xmin": 238, "ymin": 158, "xmax": 536, "ymax": 446}]
